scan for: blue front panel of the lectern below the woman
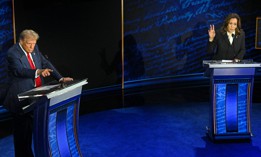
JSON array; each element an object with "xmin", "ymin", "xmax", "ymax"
[{"xmin": 215, "ymin": 83, "xmax": 250, "ymax": 134}]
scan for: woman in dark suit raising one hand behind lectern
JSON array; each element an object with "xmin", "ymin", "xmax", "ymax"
[{"xmin": 208, "ymin": 13, "xmax": 246, "ymax": 62}]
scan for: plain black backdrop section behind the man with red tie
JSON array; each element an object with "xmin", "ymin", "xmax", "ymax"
[{"xmin": 12, "ymin": 0, "xmax": 121, "ymax": 89}]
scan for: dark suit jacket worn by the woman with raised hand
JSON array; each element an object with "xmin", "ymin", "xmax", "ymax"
[{"xmin": 208, "ymin": 30, "xmax": 246, "ymax": 60}]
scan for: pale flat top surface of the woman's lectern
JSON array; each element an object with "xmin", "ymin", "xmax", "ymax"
[{"xmin": 203, "ymin": 60, "xmax": 261, "ymax": 68}]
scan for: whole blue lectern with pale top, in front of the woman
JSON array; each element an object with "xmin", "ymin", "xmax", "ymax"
[{"xmin": 203, "ymin": 60, "xmax": 261, "ymax": 141}]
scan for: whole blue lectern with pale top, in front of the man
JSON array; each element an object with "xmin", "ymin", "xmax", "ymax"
[{"xmin": 18, "ymin": 79, "xmax": 88, "ymax": 157}]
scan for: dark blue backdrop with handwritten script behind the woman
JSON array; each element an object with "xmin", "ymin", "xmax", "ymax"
[{"xmin": 124, "ymin": 0, "xmax": 260, "ymax": 81}]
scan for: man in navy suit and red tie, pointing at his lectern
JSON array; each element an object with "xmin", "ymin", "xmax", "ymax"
[{"xmin": 4, "ymin": 30, "xmax": 73, "ymax": 157}]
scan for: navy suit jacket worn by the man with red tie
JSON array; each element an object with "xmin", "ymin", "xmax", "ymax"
[{"xmin": 4, "ymin": 44, "xmax": 62, "ymax": 113}]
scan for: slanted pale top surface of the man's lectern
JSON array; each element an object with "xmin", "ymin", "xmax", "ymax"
[{"xmin": 18, "ymin": 79, "xmax": 87, "ymax": 99}]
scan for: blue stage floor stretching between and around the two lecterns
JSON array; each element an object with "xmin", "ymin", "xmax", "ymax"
[{"xmin": 0, "ymin": 86, "xmax": 261, "ymax": 157}]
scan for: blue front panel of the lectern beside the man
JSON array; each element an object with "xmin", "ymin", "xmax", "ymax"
[{"xmin": 49, "ymin": 96, "xmax": 81, "ymax": 157}]
